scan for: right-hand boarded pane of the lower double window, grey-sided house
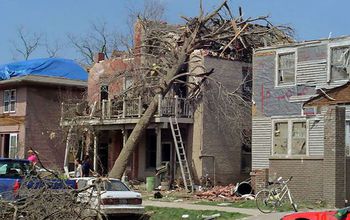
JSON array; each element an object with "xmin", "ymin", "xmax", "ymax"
[{"xmin": 292, "ymin": 122, "xmax": 306, "ymax": 155}]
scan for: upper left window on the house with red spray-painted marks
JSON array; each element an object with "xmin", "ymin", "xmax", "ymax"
[{"xmin": 277, "ymin": 52, "xmax": 295, "ymax": 85}]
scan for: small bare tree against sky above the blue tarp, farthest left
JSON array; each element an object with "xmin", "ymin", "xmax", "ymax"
[{"xmin": 13, "ymin": 26, "xmax": 42, "ymax": 60}]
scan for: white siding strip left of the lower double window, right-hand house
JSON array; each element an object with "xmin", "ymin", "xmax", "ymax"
[{"xmin": 252, "ymin": 118, "xmax": 271, "ymax": 169}]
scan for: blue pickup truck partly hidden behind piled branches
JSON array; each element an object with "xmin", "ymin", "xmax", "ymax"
[{"xmin": 0, "ymin": 158, "xmax": 76, "ymax": 200}]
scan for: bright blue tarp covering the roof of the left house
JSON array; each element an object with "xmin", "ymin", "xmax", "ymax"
[{"xmin": 0, "ymin": 58, "xmax": 88, "ymax": 81}]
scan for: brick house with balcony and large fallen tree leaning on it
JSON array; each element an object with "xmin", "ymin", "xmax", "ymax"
[{"xmin": 62, "ymin": 21, "xmax": 251, "ymax": 184}]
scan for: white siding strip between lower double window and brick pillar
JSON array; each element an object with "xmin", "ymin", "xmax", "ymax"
[{"xmin": 309, "ymin": 116, "xmax": 324, "ymax": 156}]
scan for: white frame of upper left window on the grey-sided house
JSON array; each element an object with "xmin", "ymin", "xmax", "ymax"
[{"xmin": 275, "ymin": 48, "xmax": 298, "ymax": 87}]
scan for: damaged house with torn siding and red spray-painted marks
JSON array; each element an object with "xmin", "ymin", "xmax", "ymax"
[{"xmin": 251, "ymin": 37, "xmax": 350, "ymax": 207}]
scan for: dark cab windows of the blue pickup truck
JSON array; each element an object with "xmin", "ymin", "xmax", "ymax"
[{"xmin": 0, "ymin": 160, "xmax": 29, "ymax": 178}]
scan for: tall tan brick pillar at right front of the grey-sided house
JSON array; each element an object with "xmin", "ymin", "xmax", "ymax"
[{"xmin": 322, "ymin": 106, "xmax": 345, "ymax": 207}]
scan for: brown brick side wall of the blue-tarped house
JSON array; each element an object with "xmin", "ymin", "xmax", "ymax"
[{"xmin": 25, "ymin": 86, "xmax": 83, "ymax": 169}]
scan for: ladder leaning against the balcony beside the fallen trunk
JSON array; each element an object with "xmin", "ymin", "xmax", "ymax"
[{"xmin": 169, "ymin": 117, "xmax": 193, "ymax": 192}]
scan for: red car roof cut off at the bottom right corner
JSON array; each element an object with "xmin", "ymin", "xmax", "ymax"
[{"xmin": 281, "ymin": 207, "xmax": 350, "ymax": 220}]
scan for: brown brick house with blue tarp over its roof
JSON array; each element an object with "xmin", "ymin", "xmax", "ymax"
[{"xmin": 0, "ymin": 58, "xmax": 87, "ymax": 169}]
